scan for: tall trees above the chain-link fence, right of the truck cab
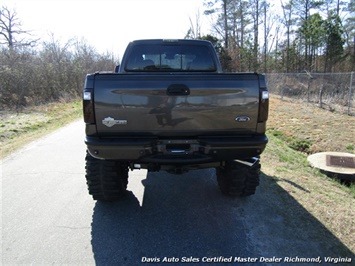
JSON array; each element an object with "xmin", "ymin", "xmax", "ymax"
[{"xmin": 192, "ymin": 0, "xmax": 355, "ymax": 73}]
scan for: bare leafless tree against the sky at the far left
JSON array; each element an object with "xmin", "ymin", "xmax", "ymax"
[{"xmin": 0, "ymin": 6, "xmax": 38, "ymax": 49}]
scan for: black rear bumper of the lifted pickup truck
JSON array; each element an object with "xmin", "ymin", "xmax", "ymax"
[{"xmin": 85, "ymin": 135, "xmax": 268, "ymax": 165}]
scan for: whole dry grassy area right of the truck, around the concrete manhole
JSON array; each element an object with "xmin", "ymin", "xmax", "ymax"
[{"xmin": 262, "ymin": 95, "xmax": 355, "ymax": 253}]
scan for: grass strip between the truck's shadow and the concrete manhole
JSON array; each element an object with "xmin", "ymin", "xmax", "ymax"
[{"xmin": 261, "ymin": 134, "xmax": 355, "ymax": 252}]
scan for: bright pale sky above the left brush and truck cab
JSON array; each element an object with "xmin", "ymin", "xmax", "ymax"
[{"xmin": 0, "ymin": 0, "xmax": 209, "ymax": 58}]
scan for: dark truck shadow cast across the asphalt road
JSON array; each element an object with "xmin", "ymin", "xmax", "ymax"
[{"xmin": 92, "ymin": 169, "xmax": 352, "ymax": 265}]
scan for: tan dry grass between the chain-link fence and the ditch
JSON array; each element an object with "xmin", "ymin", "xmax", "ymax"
[{"xmin": 268, "ymin": 97, "xmax": 355, "ymax": 153}]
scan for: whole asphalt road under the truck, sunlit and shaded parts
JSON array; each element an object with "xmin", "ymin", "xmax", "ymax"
[{"xmin": 0, "ymin": 121, "xmax": 350, "ymax": 265}]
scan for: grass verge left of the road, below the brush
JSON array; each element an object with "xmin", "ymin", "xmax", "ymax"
[{"xmin": 0, "ymin": 100, "xmax": 82, "ymax": 159}]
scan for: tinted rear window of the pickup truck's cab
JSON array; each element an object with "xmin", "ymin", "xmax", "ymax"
[{"xmin": 125, "ymin": 45, "xmax": 217, "ymax": 72}]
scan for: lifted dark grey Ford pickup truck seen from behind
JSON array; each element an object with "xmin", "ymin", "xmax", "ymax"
[{"xmin": 83, "ymin": 40, "xmax": 269, "ymax": 201}]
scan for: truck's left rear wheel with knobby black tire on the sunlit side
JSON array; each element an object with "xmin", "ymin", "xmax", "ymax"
[{"xmin": 85, "ymin": 153, "xmax": 128, "ymax": 201}]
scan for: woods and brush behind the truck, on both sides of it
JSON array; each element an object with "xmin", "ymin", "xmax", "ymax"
[{"xmin": 0, "ymin": 0, "xmax": 355, "ymax": 111}]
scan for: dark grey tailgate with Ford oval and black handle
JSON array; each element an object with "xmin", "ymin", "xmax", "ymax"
[{"xmin": 94, "ymin": 73, "xmax": 260, "ymax": 137}]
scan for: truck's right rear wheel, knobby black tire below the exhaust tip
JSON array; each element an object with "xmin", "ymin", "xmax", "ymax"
[{"xmin": 216, "ymin": 161, "xmax": 260, "ymax": 197}]
